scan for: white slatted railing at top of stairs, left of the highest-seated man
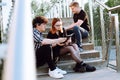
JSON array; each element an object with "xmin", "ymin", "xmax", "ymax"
[{"xmin": 45, "ymin": 0, "xmax": 73, "ymax": 18}]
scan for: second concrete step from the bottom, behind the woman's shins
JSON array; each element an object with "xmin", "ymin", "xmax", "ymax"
[{"xmin": 60, "ymin": 50, "xmax": 100, "ymax": 60}]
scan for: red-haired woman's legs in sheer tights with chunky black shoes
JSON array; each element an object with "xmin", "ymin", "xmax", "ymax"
[{"xmin": 60, "ymin": 44, "xmax": 96, "ymax": 72}]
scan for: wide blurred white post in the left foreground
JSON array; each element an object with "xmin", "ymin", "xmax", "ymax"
[{"xmin": 3, "ymin": 0, "xmax": 36, "ymax": 80}]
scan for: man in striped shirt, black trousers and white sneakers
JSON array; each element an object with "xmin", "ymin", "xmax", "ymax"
[{"xmin": 33, "ymin": 16, "xmax": 66, "ymax": 78}]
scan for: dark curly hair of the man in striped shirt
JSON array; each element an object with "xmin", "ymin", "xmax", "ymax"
[{"xmin": 32, "ymin": 16, "xmax": 48, "ymax": 28}]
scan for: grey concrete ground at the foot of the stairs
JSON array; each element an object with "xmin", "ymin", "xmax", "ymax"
[{"xmin": 37, "ymin": 68, "xmax": 120, "ymax": 80}]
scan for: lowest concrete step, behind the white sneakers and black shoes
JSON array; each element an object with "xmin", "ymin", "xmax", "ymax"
[{"xmin": 37, "ymin": 58, "xmax": 106, "ymax": 76}]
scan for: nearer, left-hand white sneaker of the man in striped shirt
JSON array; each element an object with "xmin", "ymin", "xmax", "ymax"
[{"xmin": 48, "ymin": 69, "xmax": 64, "ymax": 79}]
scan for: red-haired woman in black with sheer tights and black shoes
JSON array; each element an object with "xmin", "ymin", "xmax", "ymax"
[{"xmin": 47, "ymin": 18, "xmax": 96, "ymax": 72}]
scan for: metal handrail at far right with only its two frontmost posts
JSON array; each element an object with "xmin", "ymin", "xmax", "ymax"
[{"xmin": 95, "ymin": 0, "xmax": 120, "ymax": 72}]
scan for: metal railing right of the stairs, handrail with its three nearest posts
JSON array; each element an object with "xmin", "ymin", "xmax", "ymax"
[{"xmin": 95, "ymin": 0, "xmax": 120, "ymax": 72}]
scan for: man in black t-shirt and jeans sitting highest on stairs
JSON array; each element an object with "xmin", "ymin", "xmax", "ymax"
[{"xmin": 66, "ymin": 2, "xmax": 90, "ymax": 51}]
